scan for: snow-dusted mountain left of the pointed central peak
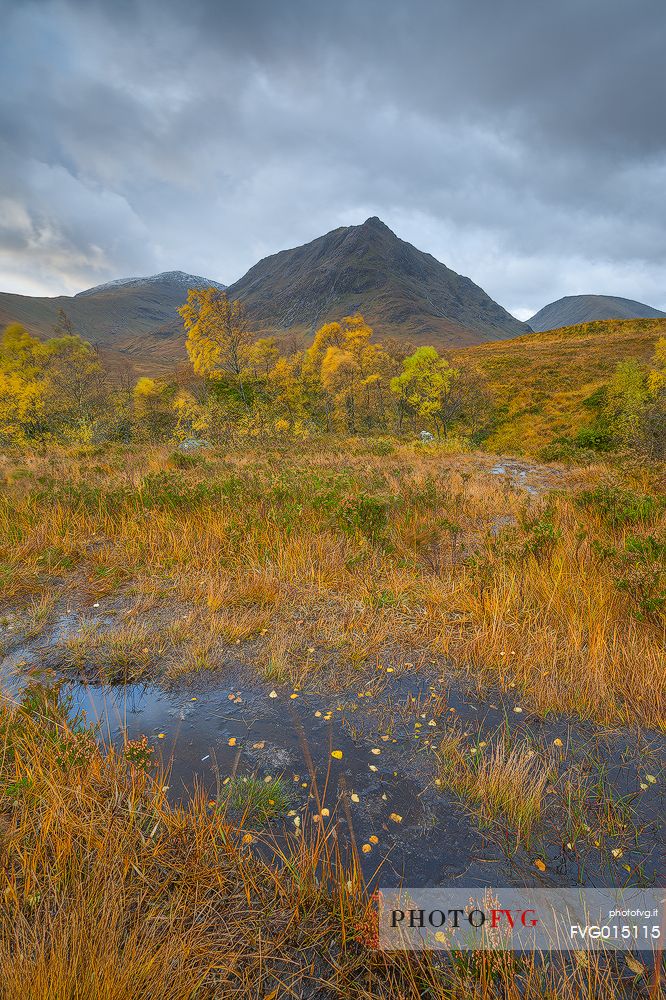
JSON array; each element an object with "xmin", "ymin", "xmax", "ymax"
[{"xmin": 0, "ymin": 271, "xmax": 225, "ymax": 361}]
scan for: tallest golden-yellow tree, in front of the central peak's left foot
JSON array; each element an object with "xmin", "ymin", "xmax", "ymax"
[{"xmin": 179, "ymin": 288, "xmax": 252, "ymax": 406}]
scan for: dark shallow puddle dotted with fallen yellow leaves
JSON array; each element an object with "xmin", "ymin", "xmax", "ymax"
[{"xmin": 0, "ymin": 615, "xmax": 664, "ymax": 887}]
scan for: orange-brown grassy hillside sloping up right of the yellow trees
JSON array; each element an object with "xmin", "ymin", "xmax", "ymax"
[{"xmin": 451, "ymin": 318, "xmax": 666, "ymax": 454}]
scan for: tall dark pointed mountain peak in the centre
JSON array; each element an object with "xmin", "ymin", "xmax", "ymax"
[{"xmin": 228, "ymin": 217, "xmax": 530, "ymax": 346}]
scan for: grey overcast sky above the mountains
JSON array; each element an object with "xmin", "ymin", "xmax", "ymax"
[{"xmin": 0, "ymin": 0, "xmax": 666, "ymax": 318}]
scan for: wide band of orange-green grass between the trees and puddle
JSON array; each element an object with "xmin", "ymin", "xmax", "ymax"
[{"xmin": 0, "ymin": 440, "xmax": 666, "ymax": 726}]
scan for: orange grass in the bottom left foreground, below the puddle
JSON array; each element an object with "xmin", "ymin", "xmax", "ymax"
[{"xmin": 0, "ymin": 688, "xmax": 658, "ymax": 1000}]
